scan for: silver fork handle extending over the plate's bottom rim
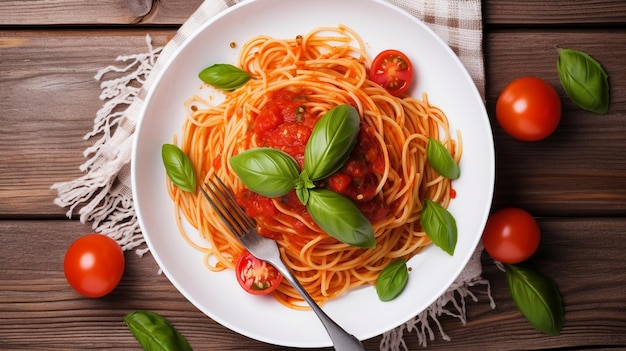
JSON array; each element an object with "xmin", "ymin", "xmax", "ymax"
[{"xmin": 272, "ymin": 261, "xmax": 365, "ymax": 351}]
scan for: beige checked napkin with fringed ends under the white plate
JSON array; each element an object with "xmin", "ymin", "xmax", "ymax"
[{"xmin": 52, "ymin": 0, "xmax": 494, "ymax": 350}]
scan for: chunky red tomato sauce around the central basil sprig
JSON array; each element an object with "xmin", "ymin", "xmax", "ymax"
[{"xmin": 237, "ymin": 91, "xmax": 389, "ymax": 240}]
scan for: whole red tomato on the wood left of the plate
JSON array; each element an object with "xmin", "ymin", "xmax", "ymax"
[{"xmin": 63, "ymin": 234, "xmax": 124, "ymax": 297}]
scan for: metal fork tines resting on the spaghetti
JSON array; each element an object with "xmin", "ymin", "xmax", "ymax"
[{"xmin": 200, "ymin": 176, "xmax": 255, "ymax": 236}]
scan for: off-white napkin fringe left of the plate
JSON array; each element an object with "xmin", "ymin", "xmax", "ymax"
[{"xmin": 51, "ymin": 35, "xmax": 162, "ymax": 256}]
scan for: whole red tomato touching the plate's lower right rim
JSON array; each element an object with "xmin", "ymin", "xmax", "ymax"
[{"xmin": 482, "ymin": 207, "xmax": 541, "ymax": 263}]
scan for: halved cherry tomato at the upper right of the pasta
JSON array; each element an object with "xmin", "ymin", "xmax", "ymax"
[{"xmin": 370, "ymin": 50, "xmax": 413, "ymax": 96}]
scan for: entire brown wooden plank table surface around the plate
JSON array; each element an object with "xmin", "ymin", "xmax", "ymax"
[{"xmin": 0, "ymin": 0, "xmax": 626, "ymax": 350}]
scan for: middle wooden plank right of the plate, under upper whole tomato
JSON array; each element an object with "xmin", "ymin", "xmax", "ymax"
[{"xmin": 485, "ymin": 30, "xmax": 626, "ymax": 216}]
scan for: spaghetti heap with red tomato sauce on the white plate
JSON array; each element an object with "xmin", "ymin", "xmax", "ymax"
[{"xmin": 168, "ymin": 26, "xmax": 462, "ymax": 309}]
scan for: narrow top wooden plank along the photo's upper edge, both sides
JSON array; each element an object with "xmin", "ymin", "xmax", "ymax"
[{"xmin": 0, "ymin": 0, "xmax": 626, "ymax": 26}]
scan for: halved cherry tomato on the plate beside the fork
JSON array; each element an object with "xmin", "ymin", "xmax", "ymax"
[{"xmin": 235, "ymin": 251, "xmax": 283, "ymax": 295}]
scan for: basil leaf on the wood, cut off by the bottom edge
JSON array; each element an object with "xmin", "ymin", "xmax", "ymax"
[{"xmin": 124, "ymin": 311, "xmax": 191, "ymax": 351}]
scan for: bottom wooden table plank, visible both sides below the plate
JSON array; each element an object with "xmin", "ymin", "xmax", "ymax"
[{"xmin": 0, "ymin": 218, "xmax": 626, "ymax": 350}]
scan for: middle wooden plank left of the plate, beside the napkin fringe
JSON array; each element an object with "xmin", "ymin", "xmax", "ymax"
[{"xmin": 0, "ymin": 30, "xmax": 174, "ymax": 216}]
